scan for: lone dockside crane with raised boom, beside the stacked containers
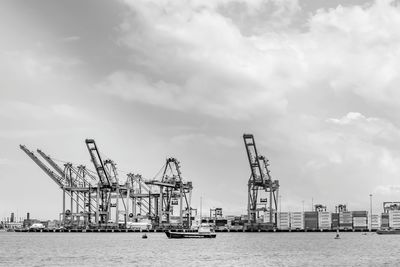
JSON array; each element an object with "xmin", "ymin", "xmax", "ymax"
[{"xmin": 243, "ymin": 134, "xmax": 279, "ymax": 227}]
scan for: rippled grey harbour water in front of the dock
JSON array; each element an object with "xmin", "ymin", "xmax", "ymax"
[{"xmin": 0, "ymin": 232, "xmax": 400, "ymax": 266}]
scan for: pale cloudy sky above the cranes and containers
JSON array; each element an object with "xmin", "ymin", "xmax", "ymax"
[{"xmin": 0, "ymin": 0, "xmax": 400, "ymax": 219}]
